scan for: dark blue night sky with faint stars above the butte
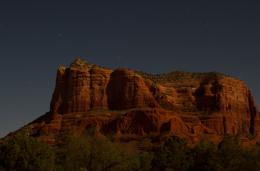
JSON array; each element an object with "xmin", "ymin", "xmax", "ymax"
[{"xmin": 0, "ymin": 0, "xmax": 260, "ymax": 136}]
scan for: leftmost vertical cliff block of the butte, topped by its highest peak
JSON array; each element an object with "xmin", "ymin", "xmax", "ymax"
[{"xmin": 51, "ymin": 59, "xmax": 112, "ymax": 114}]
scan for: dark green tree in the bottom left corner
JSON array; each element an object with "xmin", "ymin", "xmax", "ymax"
[{"xmin": 0, "ymin": 133, "xmax": 55, "ymax": 171}]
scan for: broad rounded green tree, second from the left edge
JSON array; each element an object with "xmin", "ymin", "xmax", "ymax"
[{"xmin": 58, "ymin": 136, "xmax": 126, "ymax": 171}]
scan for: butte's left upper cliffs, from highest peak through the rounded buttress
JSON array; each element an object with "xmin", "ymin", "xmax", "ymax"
[{"xmin": 51, "ymin": 59, "xmax": 158, "ymax": 114}]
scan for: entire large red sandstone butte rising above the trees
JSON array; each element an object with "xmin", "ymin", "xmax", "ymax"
[{"xmin": 17, "ymin": 59, "xmax": 260, "ymax": 144}]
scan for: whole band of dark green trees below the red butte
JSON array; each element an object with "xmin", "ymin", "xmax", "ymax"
[{"xmin": 0, "ymin": 134, "xmax": 260, "ymax": 171}]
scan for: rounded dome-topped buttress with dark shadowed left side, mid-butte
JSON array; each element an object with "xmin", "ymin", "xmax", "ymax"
[{"xmin": 107, "ymin": 69, "xmax": 158, "ymax": 110}]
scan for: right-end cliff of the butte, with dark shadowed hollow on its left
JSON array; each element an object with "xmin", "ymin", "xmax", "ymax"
[{"xmin": 196, "ymin": 77, "xmax": 257, "ymax": 135}]
